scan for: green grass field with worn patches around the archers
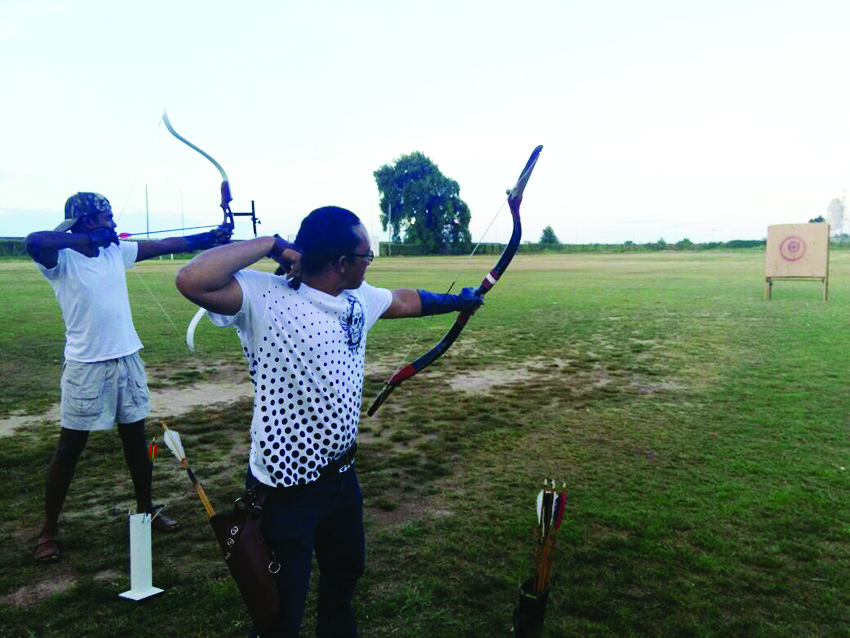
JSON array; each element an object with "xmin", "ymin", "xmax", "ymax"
[{"xmin": 0, "ymin": 251, "xmax": 850, "ymax": 638}]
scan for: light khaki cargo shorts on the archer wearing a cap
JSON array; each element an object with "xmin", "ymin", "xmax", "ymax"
[{"xmin": 61, "ymin": 352, "xmax": 150, "ymax": 431}]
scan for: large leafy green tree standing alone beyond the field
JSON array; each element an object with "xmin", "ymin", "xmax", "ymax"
[{"xmin": 373, "ymin": 151, "xmax": 472, "ymax": 254}]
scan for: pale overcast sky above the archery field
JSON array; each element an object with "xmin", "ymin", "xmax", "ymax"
[{"xmin": 0, "ymin": 0, "xmax": 850, "ymax": 243}]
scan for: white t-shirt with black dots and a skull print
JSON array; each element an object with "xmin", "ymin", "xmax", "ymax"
[{"xmin": 209, "ymin": 270, "xmax": 392, "ymax": 487}]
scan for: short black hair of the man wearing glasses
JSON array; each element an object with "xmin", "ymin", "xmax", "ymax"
[{"xmin": 295, "ymin": 206, "xmax": 361, "ymax": 275}]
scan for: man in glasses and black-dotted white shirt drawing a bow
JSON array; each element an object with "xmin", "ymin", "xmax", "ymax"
[{"xmin": 177, "ymin": 206, "xmax": 482, "ymax": 638}]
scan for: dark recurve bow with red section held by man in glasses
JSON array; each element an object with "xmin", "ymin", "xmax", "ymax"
[{"xmin": 367, "ymin": 146, "xmax": 543, "ymax": 416}]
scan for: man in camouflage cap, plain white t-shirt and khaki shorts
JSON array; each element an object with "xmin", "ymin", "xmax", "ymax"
[{"xmin": 25, "ymin": 193, "xmax": 233, "ymax": 563}]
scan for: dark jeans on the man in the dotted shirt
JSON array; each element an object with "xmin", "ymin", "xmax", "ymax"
[{"xmin": 250, "ymin": 467, "xmax": 366, "ymax": 638}]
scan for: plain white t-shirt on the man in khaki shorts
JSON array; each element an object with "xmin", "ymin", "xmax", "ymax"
[{"xmin": 36, "ymin": 242, "xmax": 142, "ymax": 363}]
